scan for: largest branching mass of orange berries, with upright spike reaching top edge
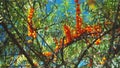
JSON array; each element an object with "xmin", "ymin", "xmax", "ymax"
[{"xmin": 55, "ymin": 0, "xmax": 102, "ymax": 52}]
